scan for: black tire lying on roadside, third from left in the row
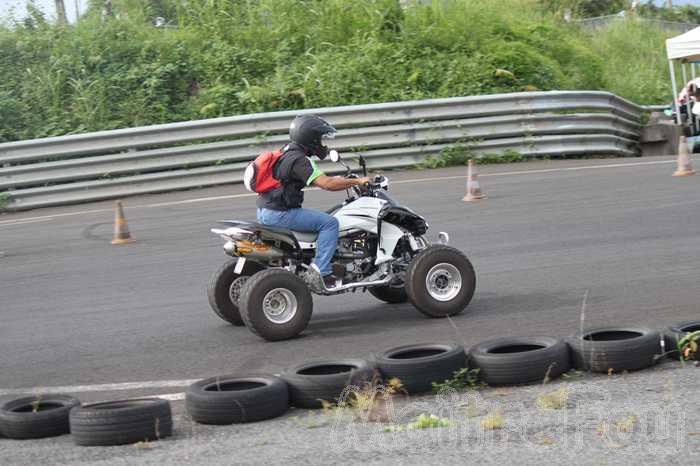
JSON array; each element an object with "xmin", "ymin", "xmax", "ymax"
[{"xmin": 185, "ymin": 375, "xmax": 289, "ymax": 425}]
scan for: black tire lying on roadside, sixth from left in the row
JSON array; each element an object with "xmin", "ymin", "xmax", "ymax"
[{"xmin": 468, "ymin": 337, "xmax": 571, "ymax": 385}]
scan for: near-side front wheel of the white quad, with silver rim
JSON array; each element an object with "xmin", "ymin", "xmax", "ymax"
[{"xmin": 406, "ymin": 245, "xmax": 476, "ymax": 317}]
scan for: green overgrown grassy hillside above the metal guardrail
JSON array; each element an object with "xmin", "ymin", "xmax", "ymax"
[{"xmin": 0, "ymin": 0, "xmax": 684, "ymax": 142}]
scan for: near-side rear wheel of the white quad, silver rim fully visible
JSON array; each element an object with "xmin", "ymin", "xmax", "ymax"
[{"xmin": 240, "ymin": 269, "xmax": 313, "ymax": 341}]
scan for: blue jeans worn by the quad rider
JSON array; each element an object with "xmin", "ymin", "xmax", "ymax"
[{"xmin": 258, "ymin": 208, "xmax": 338, "ymax": 276}]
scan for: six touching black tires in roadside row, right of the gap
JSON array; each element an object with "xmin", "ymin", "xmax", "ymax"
[{"xmin": 186, "ymin": 321, "xmax": 700, "ymax": 424}]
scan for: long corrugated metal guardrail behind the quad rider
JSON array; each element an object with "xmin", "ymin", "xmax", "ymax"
[{"xmin": 0, "ymin": 91, "xmax": 646, "ymax": 210}]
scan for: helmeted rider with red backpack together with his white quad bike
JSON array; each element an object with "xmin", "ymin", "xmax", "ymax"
[{"xmin": 208, "ymin": 115, "xmax": 476, "ymax": 340}]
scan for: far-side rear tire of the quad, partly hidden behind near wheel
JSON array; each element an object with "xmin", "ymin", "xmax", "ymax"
[{"xmin": 207, "ymin": 259, "xmax": 265, "ymax": 327}]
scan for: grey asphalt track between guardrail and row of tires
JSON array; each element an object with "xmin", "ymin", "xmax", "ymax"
[{"xmin": 0, "ymin": 158, "xmax": 700, "ymax": 399}]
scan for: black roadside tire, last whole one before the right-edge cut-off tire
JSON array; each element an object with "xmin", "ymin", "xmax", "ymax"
[{"xmin": 566, "ymin": 327, "xmax": 661, "ymax": 373}]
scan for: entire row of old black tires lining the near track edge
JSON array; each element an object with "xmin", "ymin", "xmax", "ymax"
[{"xmin": 0, "ymin": 321, "xmax": 700, "ymax": 440}]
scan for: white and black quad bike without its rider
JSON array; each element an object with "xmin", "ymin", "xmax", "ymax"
[{"xmin": 208, "ymin": 151, "xmax": 476, "ymax": 341}]
